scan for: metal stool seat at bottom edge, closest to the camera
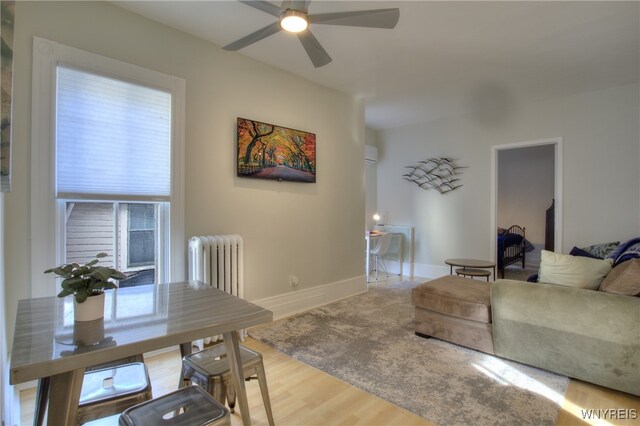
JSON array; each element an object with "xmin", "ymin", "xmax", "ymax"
[{"xmin": 119, "ymin": 386, "xmax": 231, "ymax": 426}]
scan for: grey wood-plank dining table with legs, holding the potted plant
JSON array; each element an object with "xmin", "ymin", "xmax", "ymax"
[{"xmin": 10, "ymin": 281, "xmax": 273, "ymax": 425}]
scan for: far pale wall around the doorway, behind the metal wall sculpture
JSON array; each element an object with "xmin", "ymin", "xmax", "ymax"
[{"xmin": 378, "ymin": 84, "xmax": 640, "ymax": 276}]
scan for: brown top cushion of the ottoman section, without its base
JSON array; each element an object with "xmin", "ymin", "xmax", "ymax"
[{"xmin": 411, "ymin": 275, "xmax": 491, "ymax": 323}]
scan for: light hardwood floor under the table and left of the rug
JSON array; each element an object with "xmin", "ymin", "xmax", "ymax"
[{"xmin": 20, "ymin": 338, "xmax": 433, "ymax": 426}]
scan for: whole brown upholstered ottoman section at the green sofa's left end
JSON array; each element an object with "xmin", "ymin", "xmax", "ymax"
[{"xmin": 411, "ymin": 275, "xmax": 493, "ymax": 354}]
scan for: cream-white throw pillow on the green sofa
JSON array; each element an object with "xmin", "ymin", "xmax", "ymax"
[{"xmin": 538, "ymin": 250, "xmax": 611, "ymax": 290}]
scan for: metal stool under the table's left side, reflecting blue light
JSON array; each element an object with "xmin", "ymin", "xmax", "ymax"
[{"xmin": 78, "ymin": 362, "xmax": 153, "ymax": 424}]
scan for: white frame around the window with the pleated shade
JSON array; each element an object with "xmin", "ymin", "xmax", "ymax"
[{"xmin": 31, "ymin": 37, "xmax": 186, "ymax": 297}]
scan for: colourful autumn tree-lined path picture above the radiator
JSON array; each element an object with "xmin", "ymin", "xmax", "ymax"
[{"xmin": 237, "ymin": 118, "xmax": 316, "ymax": 183}]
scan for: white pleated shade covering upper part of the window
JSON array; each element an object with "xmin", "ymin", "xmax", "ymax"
[{"xmin": 55, "ymin": 66, "xmax": 171, "ymax": 201}]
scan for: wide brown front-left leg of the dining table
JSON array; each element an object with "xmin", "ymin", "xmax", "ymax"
[{"xmin": 47, "ymin": 368, "xmax": 84, "ymax": 426}]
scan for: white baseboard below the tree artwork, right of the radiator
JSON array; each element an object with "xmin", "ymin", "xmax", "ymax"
[{"xmin": 251, "ymin": 275, "xmax": 367, "ymax": 320}]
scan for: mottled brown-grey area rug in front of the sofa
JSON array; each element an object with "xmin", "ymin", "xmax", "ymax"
[{"xmin": 249, "ymin": 282, "xmax": 568, "ymax": 425}]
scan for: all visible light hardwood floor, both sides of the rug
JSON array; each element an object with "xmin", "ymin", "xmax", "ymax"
[{"xmin": 20, "ymin": 278, "xmax": 640, "ymax": 426}]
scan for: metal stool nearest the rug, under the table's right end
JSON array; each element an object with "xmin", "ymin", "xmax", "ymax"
[{"xmin": 178, "ymin": 344, "xmax": 274, "ymax": 426}]
